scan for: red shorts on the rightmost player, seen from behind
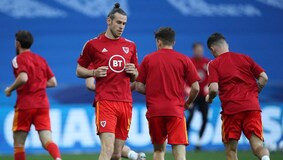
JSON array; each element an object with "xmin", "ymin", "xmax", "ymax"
[{"xmin": 221, "ymin": 111, "xmax": 263, "ymax": 143}]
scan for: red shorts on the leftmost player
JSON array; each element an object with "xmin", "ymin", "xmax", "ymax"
[{"xmin": 12, "ymin": 108, "xmax": 51, "ymax": 132}]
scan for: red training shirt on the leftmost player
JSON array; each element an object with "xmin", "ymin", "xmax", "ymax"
[{"xmin": 12, "ymin": 51, "xmax": 54, "ymax": 109}]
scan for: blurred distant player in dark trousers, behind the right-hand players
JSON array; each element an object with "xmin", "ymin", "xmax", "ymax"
[{"xmin": 187, "ymin": 42, "xmax": 209, "ymax": 150}]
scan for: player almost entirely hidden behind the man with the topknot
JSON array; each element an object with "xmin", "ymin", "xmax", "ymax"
[{"xmin": 85, "ymin": 76, "xmax": 146, "ymax": 160}]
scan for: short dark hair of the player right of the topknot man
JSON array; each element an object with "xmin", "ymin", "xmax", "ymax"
[{"xmin": 154, "ymin": 27, "xmax": 175, "ymax": 45}]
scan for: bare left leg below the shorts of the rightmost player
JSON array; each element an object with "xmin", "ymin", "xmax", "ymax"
[{"xmin": 224, "ymin": 140, "xmax": 238, "ymax": 160}]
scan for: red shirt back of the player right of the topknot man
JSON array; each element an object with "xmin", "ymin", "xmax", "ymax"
[{"xmin": 137, "ymin": 49, "xmax": 200, "ymax": 118}]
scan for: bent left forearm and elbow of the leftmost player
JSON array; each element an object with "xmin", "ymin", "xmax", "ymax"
[{"xmin": 5, "ymin": 72, "xmax": 28, "ymax": 96}]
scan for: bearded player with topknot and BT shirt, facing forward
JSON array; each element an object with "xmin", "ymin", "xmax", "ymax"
[{"xmin": 76, "ymin": 3, "xmax": 138, "ymax": 160}]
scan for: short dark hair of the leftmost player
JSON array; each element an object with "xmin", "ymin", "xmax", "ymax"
[{"xmin": 15, "ymin": 30, "xmax": 33, "ymax": 49}]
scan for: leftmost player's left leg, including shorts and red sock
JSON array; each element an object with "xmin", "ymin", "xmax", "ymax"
[{"xmin": 13, "ymin": 108, "xmax": 33, "ymax": 160}]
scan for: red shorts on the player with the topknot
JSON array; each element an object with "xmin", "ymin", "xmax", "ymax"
[{"xmin": 95, "ymin": 100, "xmax": 132, "ymax": 140}]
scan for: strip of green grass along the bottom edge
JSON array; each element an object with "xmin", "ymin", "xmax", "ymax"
[{"xmin": 0, "ymin": 151, "xmax": 283, "ymax": 160}]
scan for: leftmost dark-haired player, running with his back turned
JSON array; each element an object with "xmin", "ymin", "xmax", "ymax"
[{"xmin": 5, "ymin": 31, "xmax": 61, "ymax": 160}]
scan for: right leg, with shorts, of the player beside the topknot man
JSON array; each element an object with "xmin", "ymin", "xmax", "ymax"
[{"xmin": 169, "ymin": 117, "xmax": 189, "ymax": 160}]
